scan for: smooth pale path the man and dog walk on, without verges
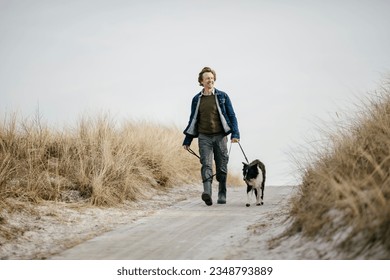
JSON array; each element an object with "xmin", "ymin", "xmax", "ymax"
[{"xmin": 52, "ymin": 186, "xmax": 292, "ymax": 260}]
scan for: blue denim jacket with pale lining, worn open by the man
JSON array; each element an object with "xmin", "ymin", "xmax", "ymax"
[{"xmin": 183, "ymin": 89, "xmax": 240, "ymax": 146}]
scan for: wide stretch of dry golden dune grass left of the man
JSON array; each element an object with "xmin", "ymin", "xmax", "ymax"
[{"xmin": 0, "ymin": 115, "xmax": 200, "ymax": 219}]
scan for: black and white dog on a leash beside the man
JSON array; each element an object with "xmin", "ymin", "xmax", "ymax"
[{"xmin": 242, "ymin": 159, "xmax": 265, "ymax": 207}]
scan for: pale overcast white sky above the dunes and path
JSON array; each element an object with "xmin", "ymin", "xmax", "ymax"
[{"xmin": 0, "ymin": 0, "xmax": 390, "ymax": 185}]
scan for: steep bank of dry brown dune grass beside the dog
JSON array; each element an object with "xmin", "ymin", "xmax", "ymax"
[{"xmin": 290, "ymin": 80, "xmax": 390, "ymax": 258}]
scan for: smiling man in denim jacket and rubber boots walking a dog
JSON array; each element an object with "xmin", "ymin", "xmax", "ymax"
[{"xmin": 183, "ymin": 67, "xmax": 240, "ymax": 206}]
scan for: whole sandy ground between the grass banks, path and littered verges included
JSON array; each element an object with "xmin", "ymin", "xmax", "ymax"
[{"xmin": 0, "ymin": 185, "xmax": 380, "ymax": 260}]
